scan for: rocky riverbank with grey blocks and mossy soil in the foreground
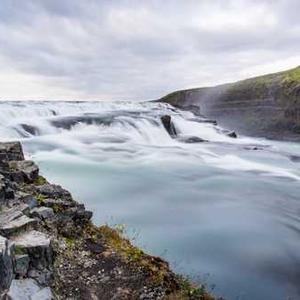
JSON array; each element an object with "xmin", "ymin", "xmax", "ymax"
[{"xmin": 0, "ymin": 142, "xmax": 214, "ymax": 300}]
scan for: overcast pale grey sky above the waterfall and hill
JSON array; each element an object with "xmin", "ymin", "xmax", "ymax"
[{"xmin": 0, "ymin": 0, "xmax": 300, "ymax": 100}]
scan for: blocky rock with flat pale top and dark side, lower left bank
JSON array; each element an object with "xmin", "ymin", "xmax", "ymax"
[{"xmin": 12, "ymin": 230, "xmax": 53, "ymax": 270}]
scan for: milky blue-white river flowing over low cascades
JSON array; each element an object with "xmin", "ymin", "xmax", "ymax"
[{"xmin": 0, "ymin": 101, "xmax": 300, "ymax": 300}]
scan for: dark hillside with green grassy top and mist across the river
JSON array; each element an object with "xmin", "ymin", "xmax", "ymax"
[{"xmin": 160, "ymin": 66, "xmax": 300, "ymax": 141}]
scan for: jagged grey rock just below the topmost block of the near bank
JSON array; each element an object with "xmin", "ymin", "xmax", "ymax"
[{"xmin": 9, "ymin": 160, "xmax": 39, "ymax": 183}]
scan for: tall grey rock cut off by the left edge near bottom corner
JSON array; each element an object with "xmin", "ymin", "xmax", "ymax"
[{"xmin": 0, "ymin": 236, "xmax": 13, "ymax": 299}]
